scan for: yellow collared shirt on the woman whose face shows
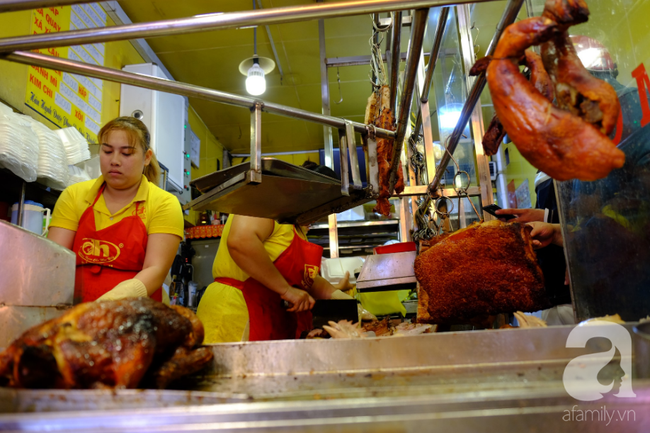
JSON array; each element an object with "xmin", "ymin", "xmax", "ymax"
[{"xmin": 50, "ymin": 175, "xmax": 184, "ymax": 239}]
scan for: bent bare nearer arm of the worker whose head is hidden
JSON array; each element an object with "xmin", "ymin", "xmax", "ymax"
[{"xmin": 227, "ymin": 215, "xmax": 315, "ymax": 312}]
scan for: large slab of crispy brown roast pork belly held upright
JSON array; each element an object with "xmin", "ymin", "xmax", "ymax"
[{"xmin": 415, "ymin": 220, "xmax": 550, "ymax": 324}]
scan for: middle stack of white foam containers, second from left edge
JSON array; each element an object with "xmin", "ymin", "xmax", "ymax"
[{"xmin": 29, "ymin": 118, "xmax": 69, "ymax": 191}]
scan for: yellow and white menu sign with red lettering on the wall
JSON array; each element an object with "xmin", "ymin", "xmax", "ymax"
[{"xmin": 25, "ymin": 3, "xmax": 106, "ymax": 143}]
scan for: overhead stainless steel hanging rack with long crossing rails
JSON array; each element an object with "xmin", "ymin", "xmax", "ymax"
[{"xmin": 0, "ymin": 0, "xmax": 522, "ymax": 248}]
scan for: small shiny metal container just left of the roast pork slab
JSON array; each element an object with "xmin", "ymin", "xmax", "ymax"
[{"xmin": 357, "ymin": 251, "xmax": 417, "ymax": 292}]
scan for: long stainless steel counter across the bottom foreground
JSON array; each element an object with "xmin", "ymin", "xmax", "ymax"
[{"xmin": 0, "ymin": 326, "xmax": 650, "ymax": 433}]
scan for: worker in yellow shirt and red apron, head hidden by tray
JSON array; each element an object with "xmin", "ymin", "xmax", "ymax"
[{"xmin": 197, "ymin": 215, "xmax": 351, "ymax": 344}]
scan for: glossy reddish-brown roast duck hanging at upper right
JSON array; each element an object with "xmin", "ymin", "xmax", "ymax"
[{"xmin": 470, "ymin": 0, "xmax": 625, "ymax": 181}]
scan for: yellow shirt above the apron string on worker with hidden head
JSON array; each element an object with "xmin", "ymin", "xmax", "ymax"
[{"xmin": 212, "ymin": 214, "xmax": 307, "ymax": 281}]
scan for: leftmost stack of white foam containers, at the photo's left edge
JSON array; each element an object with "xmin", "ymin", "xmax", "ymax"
[{"xmin": 0, "ymin": 111, "xmax": 39, "ymax": 182}]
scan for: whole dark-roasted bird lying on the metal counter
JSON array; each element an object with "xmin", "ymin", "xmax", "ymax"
[{"xmin": 0, "ymin": 298, "xmax": 213, "ymax": 389}]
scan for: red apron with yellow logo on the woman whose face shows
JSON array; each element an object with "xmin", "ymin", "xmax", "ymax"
[{"xmin": 72, "ymin": 184, "xmax": 162, "ymax": 304}]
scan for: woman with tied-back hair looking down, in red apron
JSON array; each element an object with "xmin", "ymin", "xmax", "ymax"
[{"xmin": 48, "ymin": 117, "xmax": 183, "ymax": 303}]
